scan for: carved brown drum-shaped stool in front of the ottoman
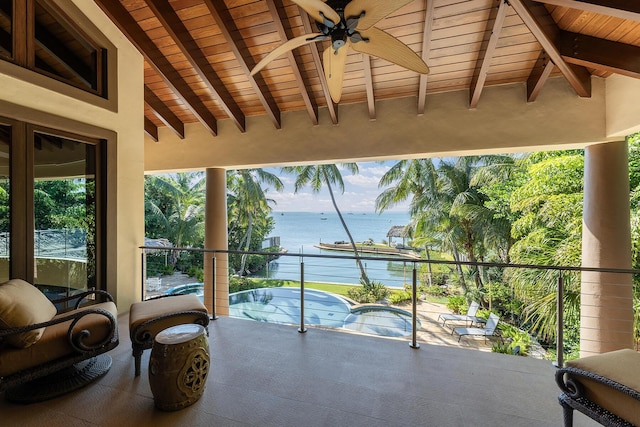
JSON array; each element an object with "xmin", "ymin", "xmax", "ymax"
[{"xmin": 149, "ymin": 324, "xmax": 209, "ymax": 411}]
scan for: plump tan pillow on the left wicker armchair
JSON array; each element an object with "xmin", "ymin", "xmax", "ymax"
[{"xmin": 0, "ymin": 279, "xmax": 57, "ymax": 348}]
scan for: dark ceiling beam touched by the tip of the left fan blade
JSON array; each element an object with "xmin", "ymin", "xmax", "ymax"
[{"xmin": 204, "ymin": 0, "xmax": 282, "ymax": 129}]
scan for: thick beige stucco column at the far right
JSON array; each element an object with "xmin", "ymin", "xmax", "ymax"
[{"xmin": 580, "ymin": 141, "xmax": 633, "ymax": 357}]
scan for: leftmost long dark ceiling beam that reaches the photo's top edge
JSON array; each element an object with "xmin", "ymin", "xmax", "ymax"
[{"xmin": 95, "ymin": 0, "xmax": 218, "ymax": 135}]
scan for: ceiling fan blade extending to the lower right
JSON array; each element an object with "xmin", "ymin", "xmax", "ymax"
[{"xmin": 351, "ymin": 27, "xmax": 429, "ymax": 74}]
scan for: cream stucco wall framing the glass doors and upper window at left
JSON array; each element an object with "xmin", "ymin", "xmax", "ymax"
[{"xmin": 0, "ymin": 0, "xmax": 144, "ymax": 311}]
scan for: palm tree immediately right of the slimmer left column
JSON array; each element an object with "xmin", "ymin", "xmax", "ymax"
[{"xmin": 227, "ymin": 168, "xmax": 284, "ymax": 276}]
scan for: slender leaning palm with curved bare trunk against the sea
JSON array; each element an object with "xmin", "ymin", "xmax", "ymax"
[{"xmin": 282, "ymin": 163, "xmax": 371, "ymax": 286}]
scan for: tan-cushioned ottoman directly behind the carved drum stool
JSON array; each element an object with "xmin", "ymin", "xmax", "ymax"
[{"xmin": 129, "ymin": 295, "xmax": 209, "ymax": 377}]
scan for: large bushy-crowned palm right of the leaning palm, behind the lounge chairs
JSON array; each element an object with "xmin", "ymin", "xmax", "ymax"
[{"xmin": 376, "ymin": 156, "xmax": 516, "ymax": 298}]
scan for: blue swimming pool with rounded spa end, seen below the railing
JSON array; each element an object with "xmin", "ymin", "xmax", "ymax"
[{"xmin": 165, "ymin": 283, "xmax": 420, "ymax": 337}]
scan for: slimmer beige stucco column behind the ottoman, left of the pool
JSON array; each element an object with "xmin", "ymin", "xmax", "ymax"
[{"xmin": 204, "ymin": 168, "xmax": 229, "ymax": 316}]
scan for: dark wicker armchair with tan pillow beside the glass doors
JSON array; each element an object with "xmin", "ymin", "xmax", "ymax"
[{"xmin": 0, "ymin": 280, "xmax": 118, "ymax": 403}]
